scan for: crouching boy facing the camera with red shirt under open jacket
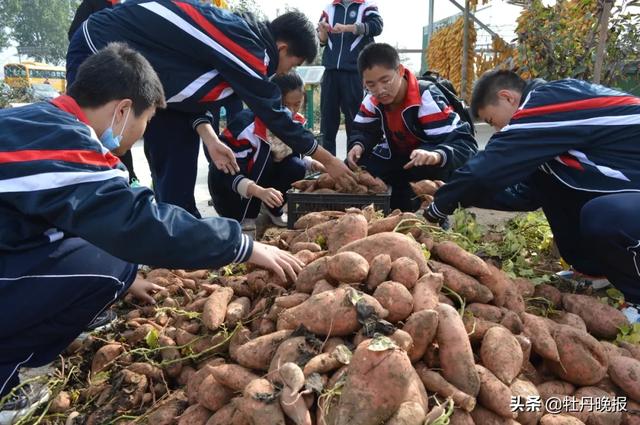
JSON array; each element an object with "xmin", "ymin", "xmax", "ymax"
[{"xmin": 347, "ymin": 43, "xmax": 477, "ymax": 211}]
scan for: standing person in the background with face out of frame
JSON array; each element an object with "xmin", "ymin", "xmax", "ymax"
[{"xmin": 317, "ymin": 0, "xmax": 383, "ymax": 155}]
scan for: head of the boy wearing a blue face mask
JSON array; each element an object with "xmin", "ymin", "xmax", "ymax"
[{"xmin": 67, "ymin": 43, "xmax": 166, "ymax": 155}]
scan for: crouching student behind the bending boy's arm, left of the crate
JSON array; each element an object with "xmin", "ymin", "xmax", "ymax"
[{"xmin": 209, "ymin": 72, "xmax": 324, "ymax": 233}]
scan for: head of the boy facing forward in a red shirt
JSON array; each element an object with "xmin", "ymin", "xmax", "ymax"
[{"xmin": 358, "ymin": 43, "xmax": 402, "ymax": 105}]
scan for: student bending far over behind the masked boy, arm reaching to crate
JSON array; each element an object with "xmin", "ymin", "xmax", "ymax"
[{"xmin": 67, "ymin": 0, "xmax": 353, "ymax": 217}]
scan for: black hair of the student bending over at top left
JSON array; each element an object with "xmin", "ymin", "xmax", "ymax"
[{"xmin": 271, "ymin": 10, "xmax": 318, "ymax": 63}]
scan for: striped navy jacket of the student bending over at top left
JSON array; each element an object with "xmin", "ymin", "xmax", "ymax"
[{"xmin": 82, "ymin": 0, "xmax": 318, "ymax": 155}]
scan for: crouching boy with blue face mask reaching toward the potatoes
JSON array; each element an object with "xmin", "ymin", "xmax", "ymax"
[{"xmin": 0, "ymin": 44, "xmax": 301, "ymax": 423}]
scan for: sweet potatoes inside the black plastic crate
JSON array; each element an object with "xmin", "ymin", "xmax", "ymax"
[{"xmin": 292, "ymin": 170, "xmax": 387, "ymax": 195}]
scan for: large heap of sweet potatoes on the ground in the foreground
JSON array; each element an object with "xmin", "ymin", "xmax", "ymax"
[{"xmin": 48, "ymin": 207, "xmax": 640, "ymax": 425}]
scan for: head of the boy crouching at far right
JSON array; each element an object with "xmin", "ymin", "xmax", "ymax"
[{"xmin": 471, "ymin": 70, "xmax": 526, "ymax": 130}]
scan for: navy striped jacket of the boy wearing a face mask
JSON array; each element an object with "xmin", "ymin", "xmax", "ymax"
[{"xmin": 0, "ymin": 96, "xmax": 253, "ymax": 266}]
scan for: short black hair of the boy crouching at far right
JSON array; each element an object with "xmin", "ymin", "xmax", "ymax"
[{"xmin": 471, "ymin": 69, "xmax": 527, "ymax": 118}]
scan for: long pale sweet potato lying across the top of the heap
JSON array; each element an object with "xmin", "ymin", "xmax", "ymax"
[{"xmin": 338, "ymin": 232, "xmax": 429, "ymax": 276}]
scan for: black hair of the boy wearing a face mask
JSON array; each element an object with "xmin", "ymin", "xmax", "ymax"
[{"xmin": 67, "ymin": 43, "xmax": 166, "ymax": 116}]
